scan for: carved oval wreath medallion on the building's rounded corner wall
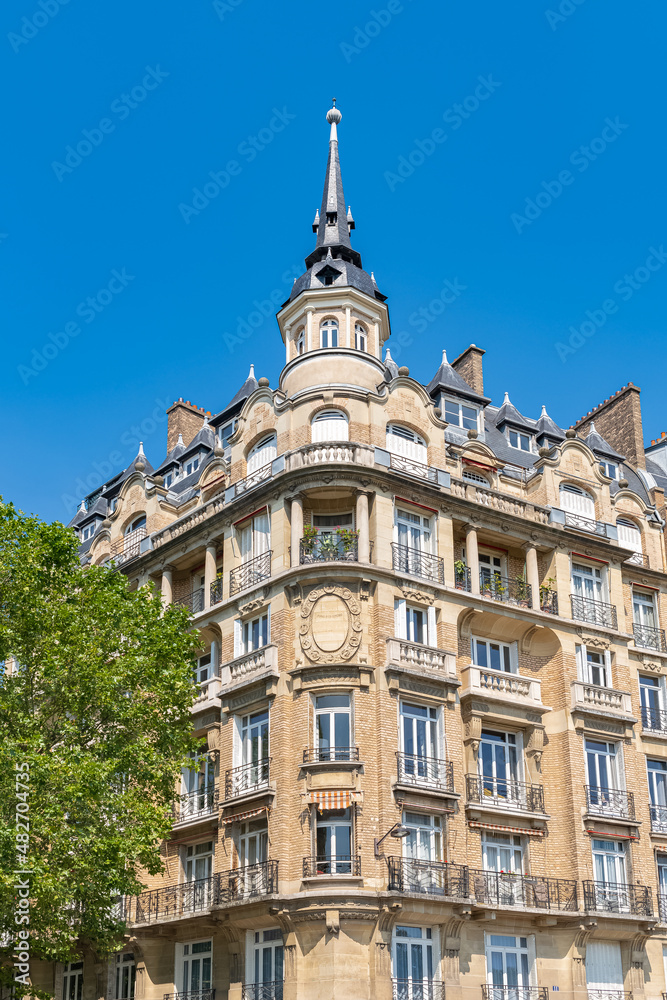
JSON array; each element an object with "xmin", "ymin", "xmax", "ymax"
[{"xmin": 299, "ymin": 583, "xmax": 362, "ymax": 663}]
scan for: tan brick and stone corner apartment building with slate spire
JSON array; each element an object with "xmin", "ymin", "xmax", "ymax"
[{"xmin": 37, "ymin": 107, "xmax": 667, "ymax": 1000}]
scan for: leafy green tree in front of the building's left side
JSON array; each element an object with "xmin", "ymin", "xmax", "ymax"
[{"xmin": 0, "ymin": 499, "xmax": 198, "ymax": 992}]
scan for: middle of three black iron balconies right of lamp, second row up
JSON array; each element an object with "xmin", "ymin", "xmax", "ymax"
[{"xmin": 469, "ymin": 869, "xmax": 579, "ymax": 910}]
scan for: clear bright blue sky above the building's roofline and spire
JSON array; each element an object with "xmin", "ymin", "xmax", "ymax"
[{"xmin": 0, "ymin": 0, "xmax": 667, "ymax": 520}]
